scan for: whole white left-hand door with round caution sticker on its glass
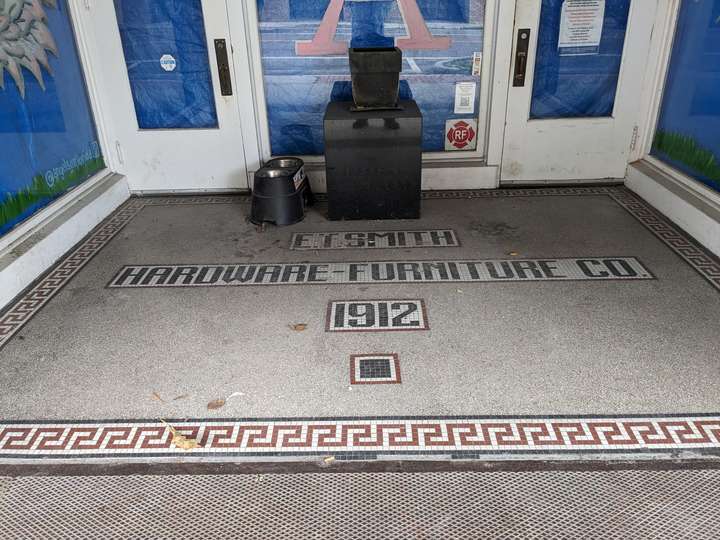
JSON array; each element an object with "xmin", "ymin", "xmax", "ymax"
[{"xmin": 92, "ymin": 0, "xmax": 247, "ymax": 192}]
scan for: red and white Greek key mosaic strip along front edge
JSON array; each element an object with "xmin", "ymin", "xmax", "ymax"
[{"xmin": 0, "ymin": 415, "xmax": 720, "ymax": 459}]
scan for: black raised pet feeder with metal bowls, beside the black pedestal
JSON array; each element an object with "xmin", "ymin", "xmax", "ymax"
[{"xmin": 250, "ymin": 158, "xmax": 315, "ymax": 227}]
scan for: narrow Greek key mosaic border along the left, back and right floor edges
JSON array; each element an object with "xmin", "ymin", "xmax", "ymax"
[{"xmin": 0, "ymin": 186, "xmax": 720, "ymax": 348}]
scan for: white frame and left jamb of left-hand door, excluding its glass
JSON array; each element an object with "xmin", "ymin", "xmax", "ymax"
[{"xmin": 69, "ymin": 0, "xmax": 254, "ymax": 194}]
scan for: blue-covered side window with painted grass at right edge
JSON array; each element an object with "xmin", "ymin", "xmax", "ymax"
[{"xmin": 652, "ymin": 0, "xmax": 720, "ymax": 191}]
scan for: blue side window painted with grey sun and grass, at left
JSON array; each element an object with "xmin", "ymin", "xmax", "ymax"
[{"xmin": 0, "ymin": 0, "xmax": 104, "ymax": 234}]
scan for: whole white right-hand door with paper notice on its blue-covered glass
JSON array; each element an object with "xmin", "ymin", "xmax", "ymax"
[{"xmin": 501, "ymin": 0, "xmax": 657, "ymax": 183}]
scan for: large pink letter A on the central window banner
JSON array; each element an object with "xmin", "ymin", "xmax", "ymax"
[{"xmin": 295, "ymin": 0, "xmax": 452, "ymax": 56}]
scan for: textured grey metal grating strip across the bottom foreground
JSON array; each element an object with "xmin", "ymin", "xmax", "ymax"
[{"xmin": 0, "ymin": 470, "xmax": 720, "ymax": 540}]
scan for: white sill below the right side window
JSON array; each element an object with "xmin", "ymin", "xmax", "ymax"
[{"xmin": 626, "ymin": 158, "xmax": 720, "ymax": 256}]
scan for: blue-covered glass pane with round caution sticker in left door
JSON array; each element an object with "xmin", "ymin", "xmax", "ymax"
[{"xmin": 115, "ymin": 0, "xmax": 218, "ymax": 129}]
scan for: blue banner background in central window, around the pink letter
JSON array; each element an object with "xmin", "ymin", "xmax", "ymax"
[{"xmin": 257, "ymin": 0, "xmax": 485, "ymax": 155}]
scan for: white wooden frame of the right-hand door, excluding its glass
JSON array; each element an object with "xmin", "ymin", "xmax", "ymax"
[{"xmin": 501, "ymin": 0, "xmax": 656, "ymax": 184}]
